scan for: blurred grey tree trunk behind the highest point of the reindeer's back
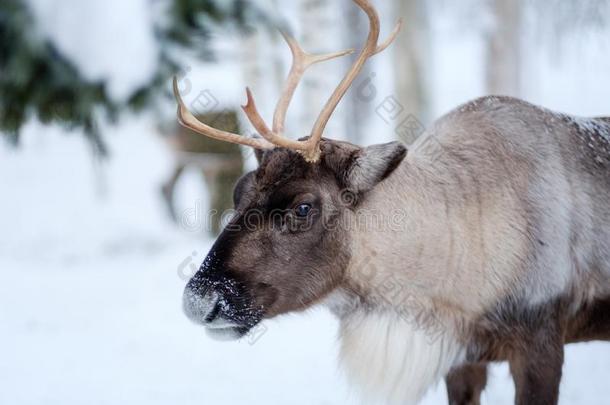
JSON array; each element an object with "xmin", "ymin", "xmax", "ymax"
[{"xmin": 485, "ymin": 0, "xmax": 522, "ymax": 97}]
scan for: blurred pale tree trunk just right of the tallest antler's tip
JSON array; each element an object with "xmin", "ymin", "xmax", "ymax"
[{"xmin": 394, "ymin": 0, "xmax": 432, "ymax": 143}]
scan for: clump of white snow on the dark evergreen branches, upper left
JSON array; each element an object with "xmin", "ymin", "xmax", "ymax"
[{"xmin": 26, "ymin": 0, "xmax": 157, "ymax": 99}]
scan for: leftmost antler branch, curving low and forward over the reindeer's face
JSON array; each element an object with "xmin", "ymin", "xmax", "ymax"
[{"xmin": 173, "ymin": 76, "xmax": 274, "ymax": 149}]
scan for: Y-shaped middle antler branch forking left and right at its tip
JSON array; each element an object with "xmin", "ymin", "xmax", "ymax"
[{"xmin": 273, "ymin": 30, "xmax": 354, "ymax": 135}]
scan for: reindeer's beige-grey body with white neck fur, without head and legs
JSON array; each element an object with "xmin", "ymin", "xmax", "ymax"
[{"xmin": 329, "ymin": 97, "xmax": 610, "ymax": 403}]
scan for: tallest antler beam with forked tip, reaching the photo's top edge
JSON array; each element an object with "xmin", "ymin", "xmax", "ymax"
[{"xmin": 305, "ymin": 0, "xmax": 402, "ymax": 161}]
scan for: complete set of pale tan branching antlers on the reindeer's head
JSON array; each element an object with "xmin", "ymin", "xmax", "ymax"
[{"xmin": 174, "ymin": 0, "xmax": 402, "ymax": 162}]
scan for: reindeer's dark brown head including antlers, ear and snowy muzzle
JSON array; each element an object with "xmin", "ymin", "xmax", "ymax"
[{"xmin": 174, "ymin": 0, "xmax": 406, "ymax": 338}]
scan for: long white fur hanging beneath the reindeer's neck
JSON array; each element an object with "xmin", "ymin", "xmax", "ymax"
[{"xmin": 334, "ymin": 296, "xmax": 464, "ymax": 405}]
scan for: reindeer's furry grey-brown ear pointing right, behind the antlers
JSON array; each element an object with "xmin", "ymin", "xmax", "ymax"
[{"xmin": 323, "ymin": 142, "xmax": 407, "ymax": 193}]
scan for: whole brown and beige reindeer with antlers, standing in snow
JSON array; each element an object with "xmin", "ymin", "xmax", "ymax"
[{"xmin": 174, "ymin": 0, "xmax": 610, "ymax": 404}]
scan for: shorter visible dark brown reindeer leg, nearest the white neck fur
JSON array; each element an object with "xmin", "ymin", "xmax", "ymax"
[{"xmin": 445, "ymin": 363, "xmax": 487, "ymax": 405}]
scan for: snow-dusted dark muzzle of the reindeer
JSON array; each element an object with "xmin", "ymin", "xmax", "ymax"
[{"xmin": 182, "ymin": 269, "xmax": 263, "ymax": 340}]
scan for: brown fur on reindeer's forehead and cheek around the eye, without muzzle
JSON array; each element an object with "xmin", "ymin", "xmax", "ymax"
[{"xmin": 225, "ymin": 149, "xmax": 349, "ymax": 317}]
